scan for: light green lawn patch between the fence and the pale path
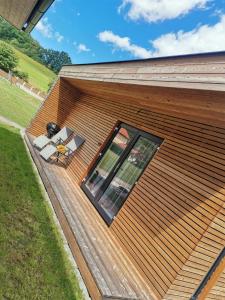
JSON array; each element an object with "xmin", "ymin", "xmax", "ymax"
[{"xmin": 0, "ymin": 78, "xmax": 41, "ymax": 127}]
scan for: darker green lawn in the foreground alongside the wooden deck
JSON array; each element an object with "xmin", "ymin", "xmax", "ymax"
[{"xmin": 0, "ymin": 124, "xmax": 83, "ymax": 300}]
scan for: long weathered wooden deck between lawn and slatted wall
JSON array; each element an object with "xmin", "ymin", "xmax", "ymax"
[{"xmin": 25, "ymin": 135, "xmax": 157, "ymax": 300}]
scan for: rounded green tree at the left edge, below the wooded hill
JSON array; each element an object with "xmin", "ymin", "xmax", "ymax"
[{"xmin": 0, "ymin": 41, "xmax": 18, "ymax": 72}]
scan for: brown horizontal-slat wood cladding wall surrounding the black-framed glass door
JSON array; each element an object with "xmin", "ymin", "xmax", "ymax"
[{"xmin": 28, "ymin": 71, "xmax": 225, "ymax": 300}]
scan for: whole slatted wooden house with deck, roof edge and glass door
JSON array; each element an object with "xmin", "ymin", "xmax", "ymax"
[{"xmin": 26, "ymin": 53, "xmax": 225, "ymax": 300}]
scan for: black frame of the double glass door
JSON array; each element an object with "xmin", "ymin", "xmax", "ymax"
[{"xmin": 81, "ymin": 122, "xmax": 163, "ymax": 226}]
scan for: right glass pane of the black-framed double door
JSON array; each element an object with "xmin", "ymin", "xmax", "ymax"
[{"xmin": 98, "ymin": 137, "xmax": 158, "ymax": 219}]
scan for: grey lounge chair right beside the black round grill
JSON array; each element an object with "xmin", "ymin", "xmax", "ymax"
[{"xmin": 33, "ymin": 127, "xmax": 73, "ymax": 150}]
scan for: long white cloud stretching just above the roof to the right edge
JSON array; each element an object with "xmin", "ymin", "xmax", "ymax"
[{"xmin": 98, "ymin": 14, "xmax": 225, "ymax": 58}]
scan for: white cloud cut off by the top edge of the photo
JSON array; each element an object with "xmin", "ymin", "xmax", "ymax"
[{"xmin": 119, "ymin": 0, "xmax": 208, "ymax": 23}]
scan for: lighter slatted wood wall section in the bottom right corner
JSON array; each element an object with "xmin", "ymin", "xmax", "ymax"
[{"xmin": 165, "ymin": 204, "xmax": 225, "ymax": 300}]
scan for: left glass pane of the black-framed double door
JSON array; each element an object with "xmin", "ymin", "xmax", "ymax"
[{"xmin": 85, "ymin": 127, "xmax": 134, "ymax": 196}]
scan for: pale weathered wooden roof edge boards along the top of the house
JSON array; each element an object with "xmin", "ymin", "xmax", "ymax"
[{"xmin": 59, "ymin": 52, "xmax": 225, "ymax": 91}]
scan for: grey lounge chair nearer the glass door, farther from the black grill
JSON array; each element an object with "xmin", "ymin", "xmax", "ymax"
[{"xmin": 40, "ymin": 135, "xmax": 85, "ymax": 163}]
